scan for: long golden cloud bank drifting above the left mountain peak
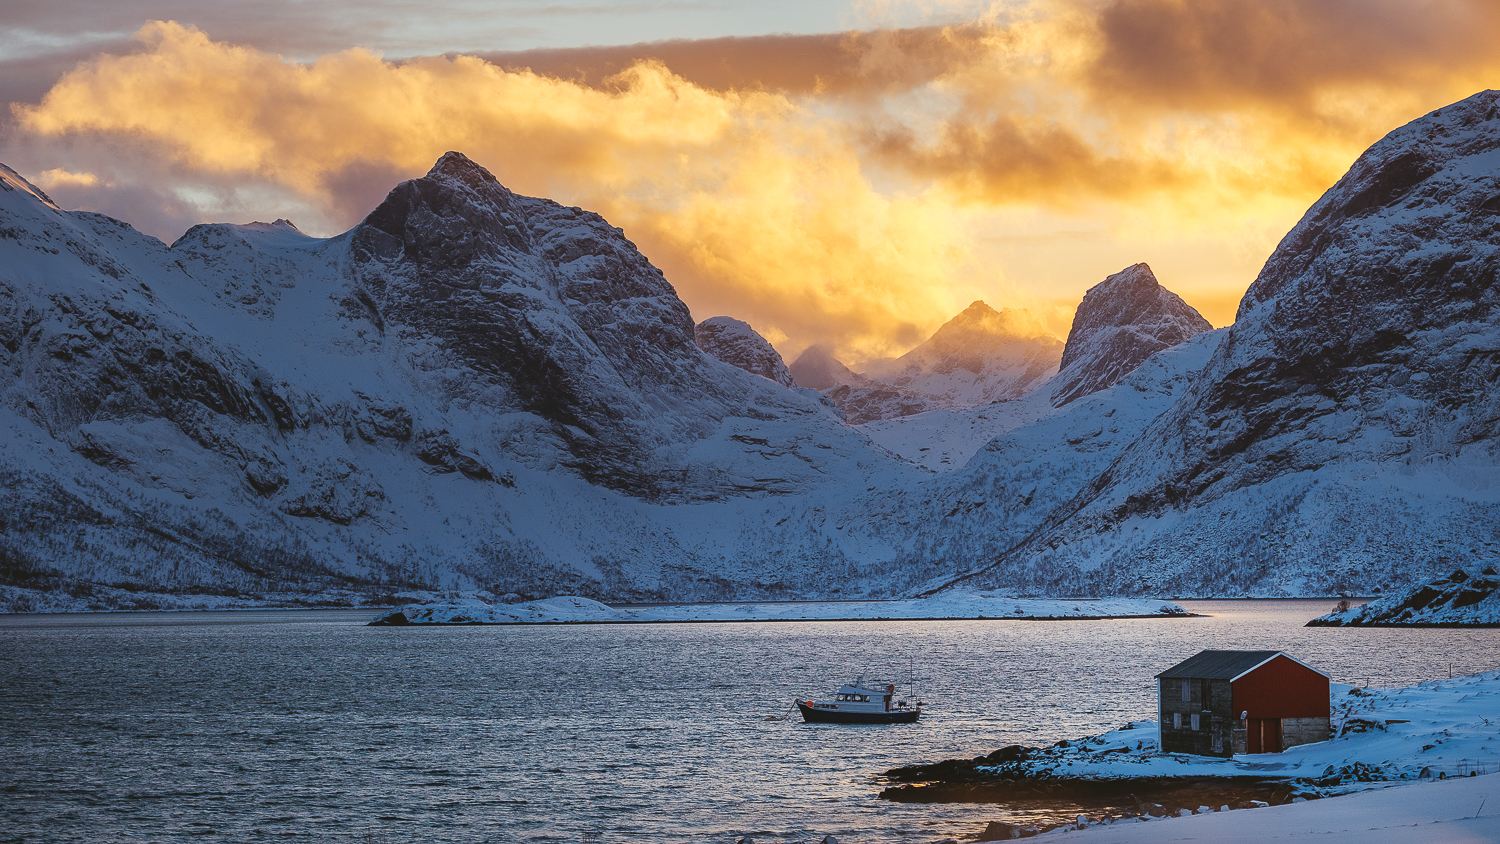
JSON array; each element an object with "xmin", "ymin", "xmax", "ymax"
[{"xmin": 17, "ymin": 22, "xmax": 971, "ymax": 355}]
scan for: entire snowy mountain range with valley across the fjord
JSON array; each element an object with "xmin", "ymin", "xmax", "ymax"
[{"xmin": 0, "ymin": 91, "xmax": 1500, "ymax": 612}]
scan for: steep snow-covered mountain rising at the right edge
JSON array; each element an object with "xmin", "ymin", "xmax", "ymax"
[{"xmin": 948, "ymin": 91, "xmax": 1500, "ymax": 594}]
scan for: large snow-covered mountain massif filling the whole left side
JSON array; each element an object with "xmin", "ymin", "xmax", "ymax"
[{"xmin": 0, "ymin": 156, "xmax": 921, "ymax": 606}]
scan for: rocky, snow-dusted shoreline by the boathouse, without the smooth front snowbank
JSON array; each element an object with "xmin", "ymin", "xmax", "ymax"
[{"xmin": 879, "ymin": 683, "xmax": 1500, "ymax": 841}]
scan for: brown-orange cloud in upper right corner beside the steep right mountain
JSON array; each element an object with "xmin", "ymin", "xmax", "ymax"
[{"xmin": 863, "ymin": 0, "xmax": 1500, "ymax": 219}]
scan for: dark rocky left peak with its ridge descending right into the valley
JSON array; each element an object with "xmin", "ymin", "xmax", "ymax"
[{"xmin": 350, "ymin": 153, "xmax": 882, "ymax": 501}]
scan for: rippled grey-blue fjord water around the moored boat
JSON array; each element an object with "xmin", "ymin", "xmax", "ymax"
[{"xmin": 0, "ymin": 601, "xmax": 1500, "ymax": 843}]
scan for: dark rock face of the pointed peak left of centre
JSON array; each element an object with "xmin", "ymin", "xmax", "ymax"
[{"xmin": 350, "ymin": 153, "xmax": 725, "ymax": 496}]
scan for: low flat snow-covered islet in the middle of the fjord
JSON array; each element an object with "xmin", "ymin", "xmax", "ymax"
[{"xmin": 372, "ymin": 592, "xmax": 1193, "ymax": 625}]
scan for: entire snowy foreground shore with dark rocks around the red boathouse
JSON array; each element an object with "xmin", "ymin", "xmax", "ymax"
[{"xmin": 881, "ymin": 672, "xmax": 1500, "ymax": 844}]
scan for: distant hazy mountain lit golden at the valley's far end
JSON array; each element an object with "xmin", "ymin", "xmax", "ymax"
[{"xmin": 791, "ymin": 301, "xmax": 1064, "ymax": 424}]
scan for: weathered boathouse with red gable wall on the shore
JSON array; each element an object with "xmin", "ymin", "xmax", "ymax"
[{"xmin": 1157, "ymin": 651, "xmax": 1331, "ymax": 756}]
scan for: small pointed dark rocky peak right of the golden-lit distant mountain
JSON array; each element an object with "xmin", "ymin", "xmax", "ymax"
[{"xmin": 1052, "ymin": 264, "xmax": 1214, "ymax": 406}]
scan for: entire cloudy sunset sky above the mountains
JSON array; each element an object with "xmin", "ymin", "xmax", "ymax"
[{"xmin": 0, "ymin": 0, "xmax": 1500, "ymax": 363}]
